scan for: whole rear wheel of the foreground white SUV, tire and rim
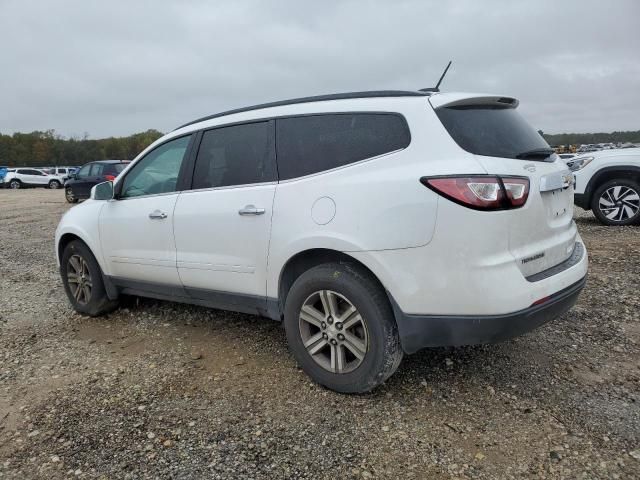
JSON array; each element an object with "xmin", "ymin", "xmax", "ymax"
[{"xmin": 284, "ymin": 263, "xmax": 403, "ymax": 393}]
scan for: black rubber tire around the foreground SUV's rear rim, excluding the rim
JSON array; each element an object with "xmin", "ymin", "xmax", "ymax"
[{"xmin": 284, "ymin": 263, "xmax": 403, "ymax": 393}]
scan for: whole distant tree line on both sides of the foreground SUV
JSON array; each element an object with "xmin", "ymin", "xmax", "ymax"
[{"xmin": 0, "ymin": 126, "xmax": 640, "ymax": 167}]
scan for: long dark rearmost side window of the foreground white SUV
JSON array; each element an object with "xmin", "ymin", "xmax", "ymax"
[{"xmin": 276, "ymin": 113, "xmax": 411, "ymax": 180}]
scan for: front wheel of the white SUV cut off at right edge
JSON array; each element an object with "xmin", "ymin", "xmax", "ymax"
[{"xmin": 591, "ymin": 178, "xmax": 640, "ymax": 226}]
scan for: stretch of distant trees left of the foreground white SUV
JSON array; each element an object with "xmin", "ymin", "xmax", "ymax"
[{"xmin": 0, "ymin": 130, "xmax": 162, "ymax": 167}]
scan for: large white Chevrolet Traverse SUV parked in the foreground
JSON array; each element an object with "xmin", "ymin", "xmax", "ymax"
[{"xmin": 56, "ymin": 91, "xmax": 587, "ymax": 392}]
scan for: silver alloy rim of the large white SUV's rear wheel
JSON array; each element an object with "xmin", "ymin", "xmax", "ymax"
[{"xmin": 298, "ymin": 290, "xmax": 369, "ymax": 374}]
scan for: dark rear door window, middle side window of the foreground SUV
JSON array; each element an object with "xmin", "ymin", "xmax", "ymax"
[{"xmin": 192, "ymin": 122, "xmax": 276, "ymax": 189}]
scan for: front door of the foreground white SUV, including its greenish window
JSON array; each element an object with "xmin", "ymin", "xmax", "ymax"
[{"xmin": 99, "ymin": 135, "xmax": 191, "ymax": 286}]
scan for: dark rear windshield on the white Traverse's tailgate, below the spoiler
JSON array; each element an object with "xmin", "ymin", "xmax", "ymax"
[{"xmin": 436, "ymin": 105, "xmax": 550, "ymax": 159}]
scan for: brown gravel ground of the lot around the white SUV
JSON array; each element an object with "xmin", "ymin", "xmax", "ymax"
[{"xmin": 0, "ymin": 190, "xmax": 640, "ymax": 479}]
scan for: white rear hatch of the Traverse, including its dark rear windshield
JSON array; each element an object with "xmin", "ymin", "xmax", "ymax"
[{"xmin": 431, "ymin": 94, "xmax": 577, "ymax": 277}]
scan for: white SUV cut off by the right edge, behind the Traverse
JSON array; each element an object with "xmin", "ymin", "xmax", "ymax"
[{"xmin": 566, "ymin": 148, "xmax": 640, "ymax": 225}]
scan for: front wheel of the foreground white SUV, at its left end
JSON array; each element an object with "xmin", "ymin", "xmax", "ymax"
[{"xmin": 60, "ymin": 240, "xmax": 118, "ymax": 317}]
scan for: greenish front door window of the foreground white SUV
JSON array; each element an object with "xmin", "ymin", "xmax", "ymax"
[{"xmin": 120, "ymin": 135, "xmax": 191, "ymax": 198}]
